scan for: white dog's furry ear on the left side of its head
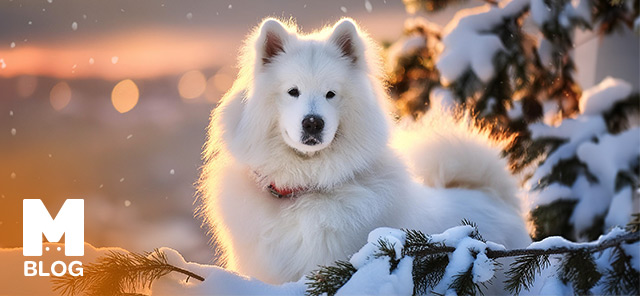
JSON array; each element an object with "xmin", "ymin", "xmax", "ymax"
[{"xmin": 256, "ymin": 18, "xmax": 290, "ymax": 65}]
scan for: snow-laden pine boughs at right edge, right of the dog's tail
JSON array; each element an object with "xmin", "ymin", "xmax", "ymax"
[{"xmin": 528, "ymin": 78, "xmax": 640, "ymax": 241}]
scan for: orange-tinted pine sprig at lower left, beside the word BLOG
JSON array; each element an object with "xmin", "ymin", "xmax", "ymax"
[{"xmin": 52, "ymin": 249, "xmax": 204, "ymax": 296}]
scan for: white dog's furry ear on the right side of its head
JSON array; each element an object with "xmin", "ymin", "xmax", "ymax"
[{"xmin": 329, "ymin": 19, "xmax": 364, "ymax": 64}]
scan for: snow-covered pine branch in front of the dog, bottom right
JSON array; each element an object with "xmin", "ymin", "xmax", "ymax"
[{"xmin": 307, "ymin": 223, "xmax": 640, "ymax": 295}]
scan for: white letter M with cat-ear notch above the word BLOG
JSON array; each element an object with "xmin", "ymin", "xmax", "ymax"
[{"xmin": 22, "ymin": 199, "xmax": 84, "ymax": 256}]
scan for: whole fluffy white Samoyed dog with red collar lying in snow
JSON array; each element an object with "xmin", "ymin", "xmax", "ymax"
[{"xmin": 199, "ymin": 18, "xmax": 530, "ymax": 284}]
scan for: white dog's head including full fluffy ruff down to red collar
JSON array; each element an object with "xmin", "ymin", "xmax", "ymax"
[{"xmin": 211, "ymin": 19, "xmax": 387, "ymax": 188}]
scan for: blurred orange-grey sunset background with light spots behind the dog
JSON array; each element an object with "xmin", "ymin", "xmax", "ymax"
[{"xmin": 0, "ymin": 0, "xmax": 638, "ymax": 263}]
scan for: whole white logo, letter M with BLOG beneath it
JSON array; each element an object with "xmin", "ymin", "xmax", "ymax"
[{"xmin": 22, "ymin": 199, "xmax": 84, "ymax": 276}]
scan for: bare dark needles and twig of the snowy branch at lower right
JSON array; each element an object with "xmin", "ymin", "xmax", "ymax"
[{"xmin": 307, "ymin": 227, "xmax": 640, "ymax": 295}]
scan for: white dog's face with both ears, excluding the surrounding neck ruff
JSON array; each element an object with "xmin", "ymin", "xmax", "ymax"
[{"xmin": 255, "ymin": 19, "xmax": 366, "ymax": 154}]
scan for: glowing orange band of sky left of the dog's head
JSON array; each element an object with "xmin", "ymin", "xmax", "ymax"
[{"xmin": 0, "ymin": 28, "xmax": 239, "ymax": 80}]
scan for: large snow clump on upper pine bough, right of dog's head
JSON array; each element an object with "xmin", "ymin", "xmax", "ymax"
[{"xmin": 436, "ymin": 0, "xmax": 529, "ymax": 85}]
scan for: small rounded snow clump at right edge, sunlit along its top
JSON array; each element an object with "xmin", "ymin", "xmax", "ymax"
[{"xmin": 580, "ymin": 77, "xmax": 633, "ymax": 115}]
